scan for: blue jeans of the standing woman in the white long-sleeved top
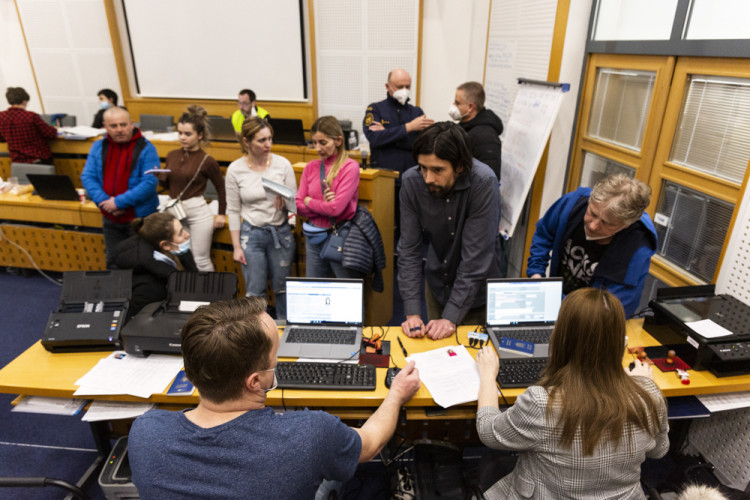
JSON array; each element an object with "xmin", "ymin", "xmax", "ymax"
[{"xmin": 240, "ymin": 221, "xmax": 295, "ymax": 319}]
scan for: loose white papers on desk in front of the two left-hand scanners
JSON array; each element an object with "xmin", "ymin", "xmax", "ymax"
[{"xmin": 73, "ymin": 351, "xmax": 182, "ymax": 398}]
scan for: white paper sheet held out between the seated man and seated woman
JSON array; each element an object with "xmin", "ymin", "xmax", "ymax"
[{"xmin": 406, "ymin": 345, "xmax": 479, "ymax": 408}]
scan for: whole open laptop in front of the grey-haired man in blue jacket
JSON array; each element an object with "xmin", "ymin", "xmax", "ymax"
[{"xmin": 485, "ymin": 278, "xmax": 562, "ymax": 359}]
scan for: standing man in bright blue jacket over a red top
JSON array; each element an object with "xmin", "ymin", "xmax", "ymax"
[{"xmin": 81, "ymin": 107, "xmax": 161, "ymax": 269}]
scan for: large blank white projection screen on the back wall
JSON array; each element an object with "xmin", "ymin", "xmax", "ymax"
[{"xmin": 122, "ymin": 0, "xmax": 307, "ymax": 101}]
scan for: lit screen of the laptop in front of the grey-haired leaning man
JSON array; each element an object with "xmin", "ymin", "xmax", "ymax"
[{"xmin": 487, "ymin": 278, "xmax": 562, "ymax": 326}]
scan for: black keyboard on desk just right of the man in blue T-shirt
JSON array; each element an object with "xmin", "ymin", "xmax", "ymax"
[{"xmin": 276, "ymin": 361, "xmax": 375, "ymax": 391}]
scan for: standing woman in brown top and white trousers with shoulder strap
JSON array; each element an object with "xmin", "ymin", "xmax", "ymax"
[{"xmin": 159, "ymin": 106, "xmax": 227, "ymax": 271}]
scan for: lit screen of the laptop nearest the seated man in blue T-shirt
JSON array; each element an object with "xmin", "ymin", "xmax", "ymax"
[{"xmin": 286, "ymin": 279, "xmax": 364, "ymax": 325}]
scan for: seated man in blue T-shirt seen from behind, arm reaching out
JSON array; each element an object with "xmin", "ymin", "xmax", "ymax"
[{"xmin": 128, "ymin": 297, "xmax": 420, "ymax": 499}]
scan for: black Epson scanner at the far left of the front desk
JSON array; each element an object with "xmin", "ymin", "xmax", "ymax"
[{"xmin": 42, "ymin": 270, "xmax": 132, "ymax": 352}]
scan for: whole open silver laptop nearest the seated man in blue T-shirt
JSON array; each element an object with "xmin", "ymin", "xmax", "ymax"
[{"xmin": 278, "ymin": 278, "xmax": 365, "ymax": 359}]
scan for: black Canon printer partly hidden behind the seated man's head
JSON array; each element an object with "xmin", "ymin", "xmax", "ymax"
[{"xmin": 122, "ymin": 271, "xmax": 238, "ymax": 356}]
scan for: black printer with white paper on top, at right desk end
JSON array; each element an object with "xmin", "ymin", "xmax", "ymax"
[{"xmin": 643, "ymin": 285, "xmax": 750, "ymax": 377}]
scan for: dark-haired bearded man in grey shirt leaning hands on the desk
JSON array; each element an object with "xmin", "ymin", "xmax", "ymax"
[{"xmin": 398, "ymin": 122, "xmax": 502, "ymax": 340}]
